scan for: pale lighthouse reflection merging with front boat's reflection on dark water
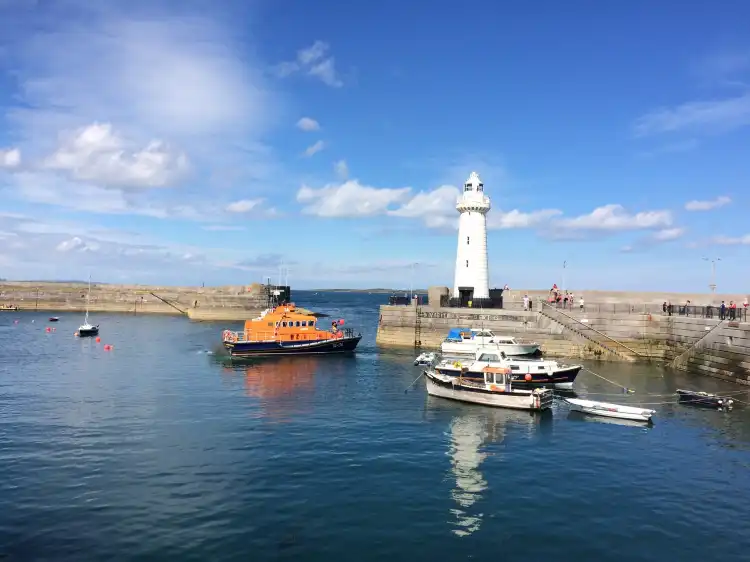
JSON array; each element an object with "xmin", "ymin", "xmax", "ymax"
[{"xmin": 428, "ymin": 397, "xmax": 552, "ymax": 537}]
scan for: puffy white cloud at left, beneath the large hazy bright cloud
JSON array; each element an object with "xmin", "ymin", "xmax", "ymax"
[{"xmin": 43, "ymin": 123, "xmax": 188, "ymax": 189}]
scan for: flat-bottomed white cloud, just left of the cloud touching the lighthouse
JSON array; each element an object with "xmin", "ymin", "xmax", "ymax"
[{"xmin": 297, "ymin": 180, "xmax": 411, "ymax": 217}]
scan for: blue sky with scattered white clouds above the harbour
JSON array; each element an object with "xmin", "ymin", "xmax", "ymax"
[{"xmin": 0, "ymin": 0, "xmax": 750, "ymax": 292}]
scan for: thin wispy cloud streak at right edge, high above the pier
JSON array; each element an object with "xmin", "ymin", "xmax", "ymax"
[{"xmin": 633, "ymin": 93, "xmax": 750, "ymax": 137}]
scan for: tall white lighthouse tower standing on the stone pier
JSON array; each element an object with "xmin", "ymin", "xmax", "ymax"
[{"xmin": 453, "ymin": 172, "xmax": 490, "ymax": 306}]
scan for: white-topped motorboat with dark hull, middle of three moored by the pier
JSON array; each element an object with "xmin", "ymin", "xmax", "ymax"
[{"xmin": 436, "ymin": 350, "xmax": 583, "ymax": 390}]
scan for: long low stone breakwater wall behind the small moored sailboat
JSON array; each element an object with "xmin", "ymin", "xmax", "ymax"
[{"xmin": 0, "ymin": 282, "xmax": 282, "ymax": 321}]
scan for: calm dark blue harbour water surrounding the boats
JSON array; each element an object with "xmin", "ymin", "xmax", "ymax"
[{"xmin": 0, "ymin": 292, "xmax": 750, "ymax": 562}]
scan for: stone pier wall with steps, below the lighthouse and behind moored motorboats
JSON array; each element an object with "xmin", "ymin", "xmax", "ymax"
[{"xmin": 376, "ymin": 301, "xmax": 750, "ymax": 385}]
